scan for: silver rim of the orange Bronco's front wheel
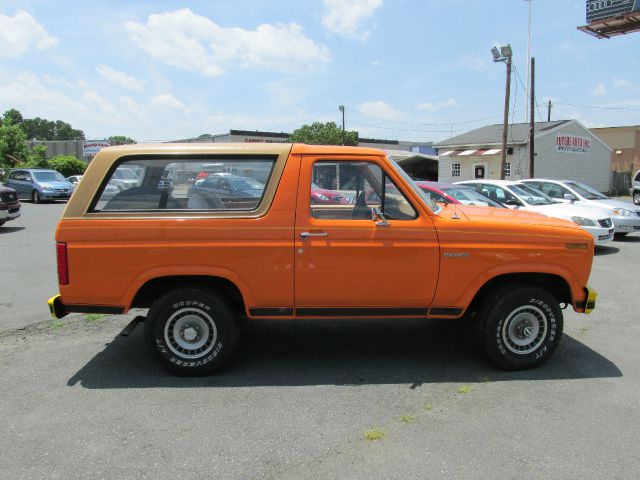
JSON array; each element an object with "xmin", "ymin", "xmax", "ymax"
[{"xmin": 502, "ymin": 305, "xmax": 548, "ymax": 355}]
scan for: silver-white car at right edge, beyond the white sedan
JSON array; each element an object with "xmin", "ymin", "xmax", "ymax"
[{"xmin": 521, "ymin": 178, "xmax": 640, "ymax": 237}]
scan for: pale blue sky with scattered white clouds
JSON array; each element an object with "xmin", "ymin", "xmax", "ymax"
[{"xmin": 0, "ymin": 0, "xmax": 640, "ymax": 142}]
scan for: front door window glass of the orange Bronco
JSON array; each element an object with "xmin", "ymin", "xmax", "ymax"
[{"xmin": 311, "ymin": 161, "xmax": 417, "ymax": 220}]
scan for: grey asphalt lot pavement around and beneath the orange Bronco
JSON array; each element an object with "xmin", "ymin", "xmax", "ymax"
[{"xmin": 0, "ymin": 204, "xmax": 640, "ymax": 479}]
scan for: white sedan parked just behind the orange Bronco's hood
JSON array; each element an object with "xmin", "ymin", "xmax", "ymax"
[{"xmin": 458, "ymin": 180, "xmax": 614, "ymax": 244}]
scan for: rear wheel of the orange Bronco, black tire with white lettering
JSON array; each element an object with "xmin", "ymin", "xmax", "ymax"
[{"xmin": 144, "ymin": 287, "xmax": 240, "ymax": 376}]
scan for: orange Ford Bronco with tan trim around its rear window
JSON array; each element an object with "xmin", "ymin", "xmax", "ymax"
[{"xmin": 49, "ymin": 144, "xmax": 595, "ymax": 375}]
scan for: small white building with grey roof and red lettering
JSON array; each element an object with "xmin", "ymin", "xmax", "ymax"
[{"xmin": 434, "ymin": 120, "xmax": 611, "ymax": 192}]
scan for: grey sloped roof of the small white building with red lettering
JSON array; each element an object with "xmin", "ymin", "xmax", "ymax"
[{"xmin": 434, "ymin": 120, "xmax": 572, "ymax": 148}]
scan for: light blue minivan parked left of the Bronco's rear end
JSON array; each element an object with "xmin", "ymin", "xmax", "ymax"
[{"xmin": 5, "ymin": 168, "xmax": 74, "ymax": 203}]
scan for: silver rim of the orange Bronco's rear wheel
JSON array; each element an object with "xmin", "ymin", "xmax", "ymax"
[{"xmin": 164, "ymin": 307, "xmax": 218, "ymax": 359}]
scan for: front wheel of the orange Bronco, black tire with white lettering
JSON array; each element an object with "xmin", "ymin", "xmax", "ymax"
[{"xmin": 478, "ymin": 283, "xmax": 563, "ymax": 370}]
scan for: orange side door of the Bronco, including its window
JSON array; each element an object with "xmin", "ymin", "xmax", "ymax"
[{"xmin": 295, "ymin": 156, "xmax": 439, "ymax": 317}]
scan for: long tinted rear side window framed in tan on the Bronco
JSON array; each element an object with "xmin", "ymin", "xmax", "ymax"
[{"xmin": 93, "ymin": 156, "xmax": 276, "ymax": 212}]
